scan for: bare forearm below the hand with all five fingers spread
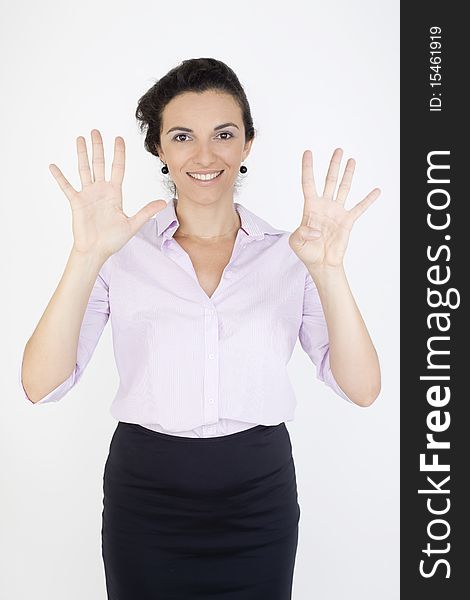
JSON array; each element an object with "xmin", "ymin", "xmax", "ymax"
[{"xmin": 22, "ymin": 244, "xmax": 105, "ymax": 402}]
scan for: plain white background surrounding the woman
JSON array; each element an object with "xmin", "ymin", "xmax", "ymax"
[{"xmin": 0, "ymin": 0, "xmax": 400, "ymax": 600}]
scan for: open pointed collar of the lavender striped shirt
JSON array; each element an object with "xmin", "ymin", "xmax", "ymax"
[{"xmin": 155, "ymin": 198, "xmax": 284, "ymax": 245}]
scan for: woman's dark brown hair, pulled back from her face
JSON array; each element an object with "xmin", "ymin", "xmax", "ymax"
[{"xmin": 135, "ymin": 58, "xmax": 255, "ymax": 195}]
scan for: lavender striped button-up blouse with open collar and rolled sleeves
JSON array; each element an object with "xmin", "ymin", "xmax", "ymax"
[{"xmin": 19, "ymin": 198, "xmax": 352, "ymax": 437}]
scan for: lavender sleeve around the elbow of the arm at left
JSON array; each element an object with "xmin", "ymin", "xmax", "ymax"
[{"xmin": 18, "ymin": 259, "xmax": 110, "ymax": 405}]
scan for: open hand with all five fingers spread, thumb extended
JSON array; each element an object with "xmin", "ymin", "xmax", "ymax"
[{"xmin": 49, "ymin": 129, "xmax": 166, "ymax": 260}]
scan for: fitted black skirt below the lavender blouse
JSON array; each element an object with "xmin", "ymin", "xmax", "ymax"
[{"xmin": 101, "ymin": 421, "xmax": 300, "ymax": 600}]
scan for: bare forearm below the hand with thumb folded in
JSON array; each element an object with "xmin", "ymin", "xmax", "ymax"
[{"xmin": 308, "ymin": 266, "xmax": 381, "ymax": 406}]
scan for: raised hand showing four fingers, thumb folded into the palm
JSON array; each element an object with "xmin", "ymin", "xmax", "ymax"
[{"xmin": 289, "ymin": 148, "xmax": 380, "ymax": 269}]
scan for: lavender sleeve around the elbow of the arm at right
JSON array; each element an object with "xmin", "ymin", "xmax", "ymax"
[{"xmin": 299, "ymin": 272, "xmax": 354, "ymax": 404}]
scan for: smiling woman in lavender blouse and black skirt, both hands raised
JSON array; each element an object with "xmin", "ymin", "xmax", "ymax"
[{"xmin": 19, "ymin": 58, "xmax": 380, "ymax": 600}]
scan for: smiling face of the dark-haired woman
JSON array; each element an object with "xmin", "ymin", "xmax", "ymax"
[{"xmin": 158, "ymin": 91, "xmax": 252, "ymax": 202}]
